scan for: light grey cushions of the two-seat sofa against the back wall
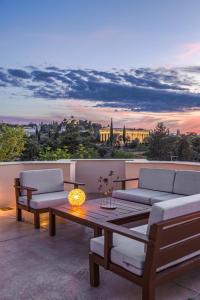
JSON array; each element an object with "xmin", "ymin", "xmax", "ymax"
[{"xmin": 112, "ymin": 168, "xmax": 200, "ymax": 205}]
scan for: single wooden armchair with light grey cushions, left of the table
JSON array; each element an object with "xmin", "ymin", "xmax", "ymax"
[{"xmin": 14, "ymin": 169, "xmax": 85, "ymax": 228}]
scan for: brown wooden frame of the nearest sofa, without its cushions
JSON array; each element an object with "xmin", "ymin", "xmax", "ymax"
[{"xmin": 89, "ymin": 212, "xmax": 200, "ymax": 300}]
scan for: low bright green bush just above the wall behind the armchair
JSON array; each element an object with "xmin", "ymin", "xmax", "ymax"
[{"xmin": 39, "ymin": 147, "xmax": 71, "ymax": 160}]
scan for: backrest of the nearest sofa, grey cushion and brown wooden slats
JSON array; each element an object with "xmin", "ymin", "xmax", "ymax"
[{"xmin": 145, "ymin": 194, "xmax": 200, "ymax": 272}]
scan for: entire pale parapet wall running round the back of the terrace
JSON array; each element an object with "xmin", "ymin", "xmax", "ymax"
[{"xmin": 0, "ymin": 159, "xmax": 200, "ymax": 207}]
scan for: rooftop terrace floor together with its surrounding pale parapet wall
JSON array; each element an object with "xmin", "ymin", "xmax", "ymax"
[{"xmin": 0, "ymin": 160, "xmax": 200, "ymax": 300}]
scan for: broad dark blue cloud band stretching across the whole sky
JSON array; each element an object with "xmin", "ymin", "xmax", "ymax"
[{"xmin": 0, "ymin": 66, "xmax": 200, "ymax": 112}]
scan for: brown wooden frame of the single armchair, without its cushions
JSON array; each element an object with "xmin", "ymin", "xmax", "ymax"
[{"xmin": 14, "ymin": 178, "xmax": 85, "ymax": 229}]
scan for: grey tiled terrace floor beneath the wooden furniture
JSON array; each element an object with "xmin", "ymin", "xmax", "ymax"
[{"xmin": 0, "ymin": 210, "xmax": 200, "ymax": 300}]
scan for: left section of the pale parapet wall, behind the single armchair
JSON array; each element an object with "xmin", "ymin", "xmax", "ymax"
[{"xmin": 0, "ymin": 160, "xmax": 76, "ymax": 207}]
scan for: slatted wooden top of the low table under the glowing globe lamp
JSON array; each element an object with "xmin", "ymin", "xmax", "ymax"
[{"xmin": 51, "ymin": 198, "xmax": 151, "ymax": 223}]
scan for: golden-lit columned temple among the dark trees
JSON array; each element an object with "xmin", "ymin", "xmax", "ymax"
[{"xmin": 99, "ymin": 127, "xmax": 149, "ymax": 143}]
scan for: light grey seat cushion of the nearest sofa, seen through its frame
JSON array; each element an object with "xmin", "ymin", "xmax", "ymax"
[{"xmin": 90, "ymin": 225, "xmax": 200, "ymax": 276}]
